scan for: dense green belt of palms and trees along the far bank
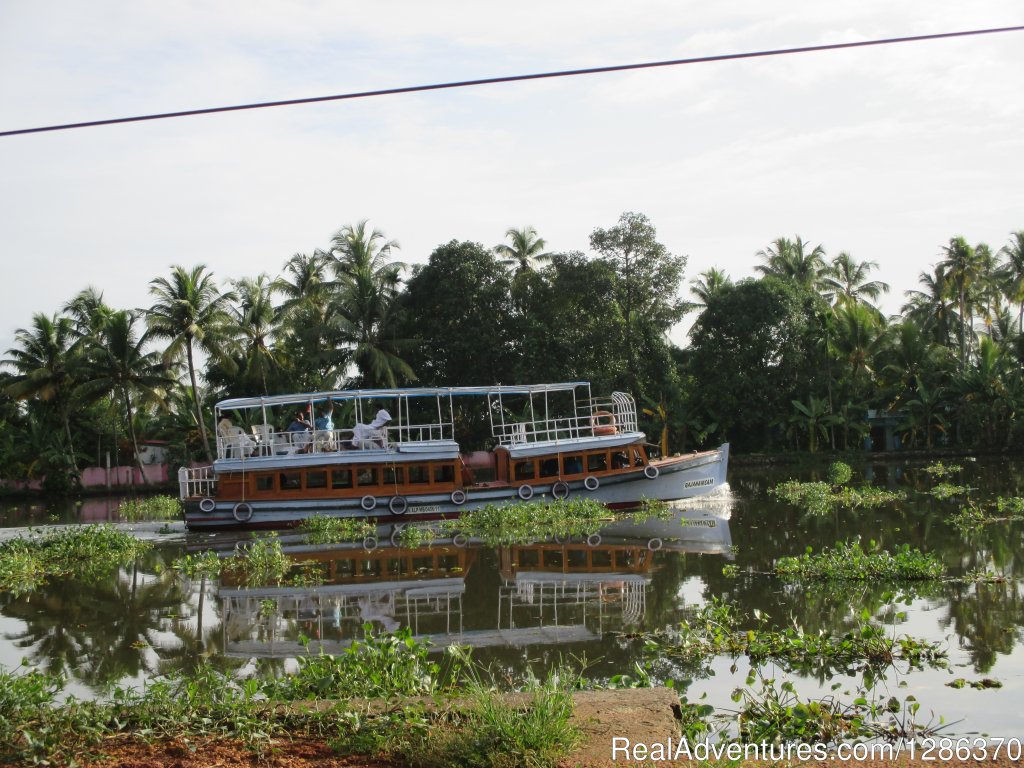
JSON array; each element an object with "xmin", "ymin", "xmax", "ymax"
[{"xmin": 0, "ymin": 217, "xmax": 1024, "ymax": 492}]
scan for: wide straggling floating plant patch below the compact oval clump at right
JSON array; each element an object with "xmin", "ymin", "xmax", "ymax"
[{"xmin": 642, "ymin": 598, "xmax": 946, "ymax": 675}]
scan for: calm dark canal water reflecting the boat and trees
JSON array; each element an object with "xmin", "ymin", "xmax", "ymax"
[{"xmin": 0, "ymin": 460, "xmax": 1024, "ymax": 736}]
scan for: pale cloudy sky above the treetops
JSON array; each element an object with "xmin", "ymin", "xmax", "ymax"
[{"xmin": 0, "ymin": 0, "xmax": 1024, "ymax": 351}]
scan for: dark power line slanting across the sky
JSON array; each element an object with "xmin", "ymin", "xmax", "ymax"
[{"xmin": 0, "ymin": 26, "xmax": 1024, "ymax": 137}]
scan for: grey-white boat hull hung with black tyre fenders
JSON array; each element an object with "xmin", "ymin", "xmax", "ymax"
[{"xmin": 184, "ymin": 444, "xmax": 729, "ymax": 530}]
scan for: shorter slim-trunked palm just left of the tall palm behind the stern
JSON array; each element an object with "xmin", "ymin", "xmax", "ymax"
[{"xmin": 82, "ymin": 310, "xmax": 174, "ymax": 482}]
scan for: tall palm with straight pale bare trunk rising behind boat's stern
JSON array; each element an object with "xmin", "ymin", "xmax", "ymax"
[{"xmin": 146, "ymin": 264, "xmax": 234, "ymax": 462}]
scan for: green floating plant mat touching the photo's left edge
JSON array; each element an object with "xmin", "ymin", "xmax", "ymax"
[{"xmin": 0, "ymin": 525, "xmax": 152, "ymax": 595}]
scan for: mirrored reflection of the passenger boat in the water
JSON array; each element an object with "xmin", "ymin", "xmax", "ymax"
[{"xmin": 219, "ymin": 505, "xmax": 732, "ymax": 658}]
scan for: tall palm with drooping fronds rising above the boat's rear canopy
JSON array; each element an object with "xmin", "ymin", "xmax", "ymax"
[{"xmin": 331, "ymin": 219, "xmax": 416, "ymax": 387}]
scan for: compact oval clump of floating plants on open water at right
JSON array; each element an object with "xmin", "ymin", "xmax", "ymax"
[{"xmin": 774, "ymin": 538, "xmax": 945, "ymax": 581}]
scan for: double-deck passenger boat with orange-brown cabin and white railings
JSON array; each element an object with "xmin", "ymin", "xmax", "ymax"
[{"xmin": 178, "ymin": 382, "xmax": 729, "ymax": 529}]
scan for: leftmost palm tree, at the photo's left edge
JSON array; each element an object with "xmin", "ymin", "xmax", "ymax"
[{"xmin": 3, "ymin": 313, "xmax": 81, "ymax": 475}]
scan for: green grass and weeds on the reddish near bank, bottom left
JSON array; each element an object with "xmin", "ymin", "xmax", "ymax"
[{"xmin": 0, "ymin": 631, "xmax": 580, "ymax": 768}]
